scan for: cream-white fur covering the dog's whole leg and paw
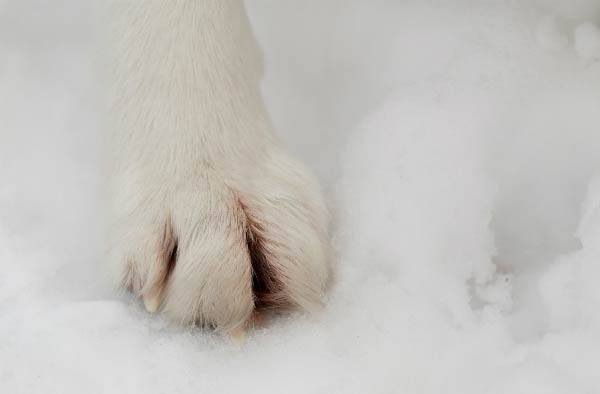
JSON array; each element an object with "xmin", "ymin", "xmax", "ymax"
[{"xmin": 103, "ymin": 0, "xmax": 328, "ymax": 331}]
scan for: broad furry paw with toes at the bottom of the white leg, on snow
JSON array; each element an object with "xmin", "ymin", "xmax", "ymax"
[{"xmin": 112, "ymin": 149, "xmax": 328, "ymax": 332}]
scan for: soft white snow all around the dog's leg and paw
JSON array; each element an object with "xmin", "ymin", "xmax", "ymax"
[{"xmin": 0, "ymin": 0, "xmax": 600, "ymax": 394}]
